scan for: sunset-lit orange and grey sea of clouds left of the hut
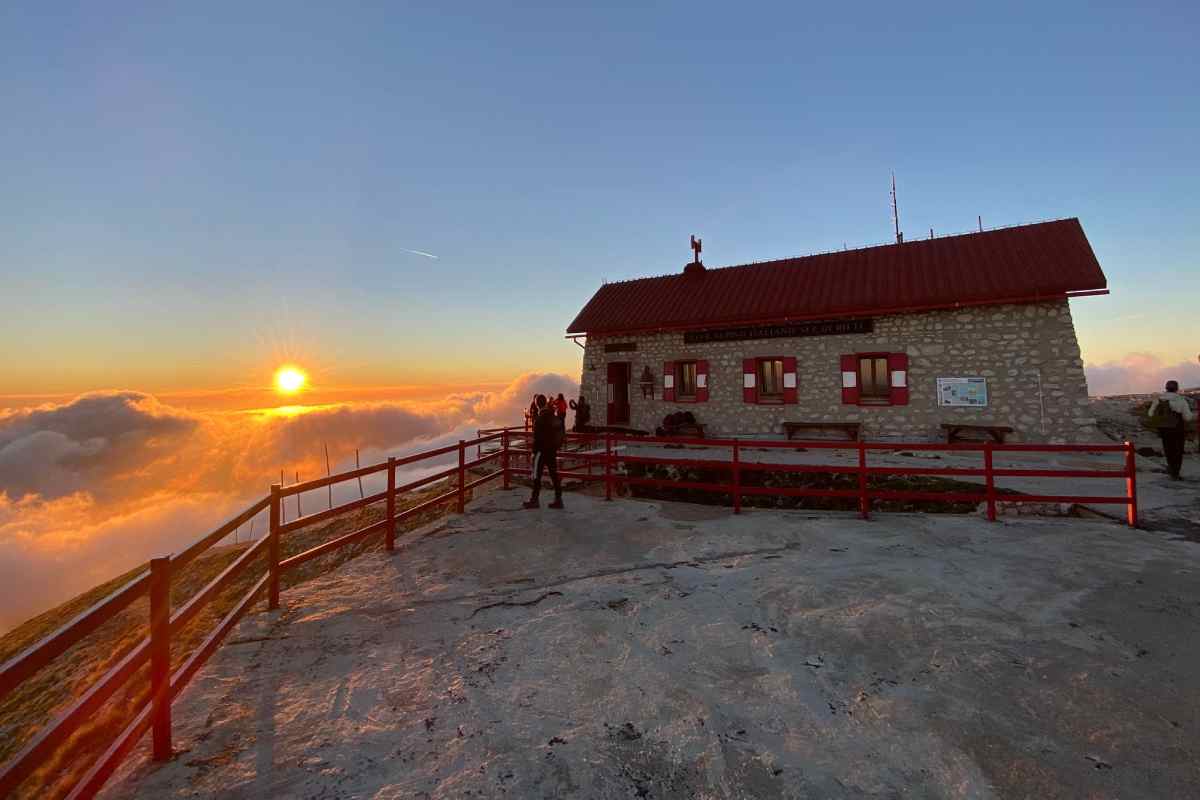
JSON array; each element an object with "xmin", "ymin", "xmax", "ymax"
[{"xmin": 0, "ymin": 373, "xmax": 578, "ymax": 632}]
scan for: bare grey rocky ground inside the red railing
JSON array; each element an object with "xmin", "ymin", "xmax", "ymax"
[{"xmin": 107, "ymin": 491, "xmax": 1200, "ymax": 799}]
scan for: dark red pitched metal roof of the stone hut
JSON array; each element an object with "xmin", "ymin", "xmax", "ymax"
[{"xmin": 566, "ymin": 218, "xmax": 1108, "ymax": 336}]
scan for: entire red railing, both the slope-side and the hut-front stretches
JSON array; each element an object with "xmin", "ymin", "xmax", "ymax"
[{"xmin": 0, "ymin": 426, "xmax": 1138, "ymax": 798}]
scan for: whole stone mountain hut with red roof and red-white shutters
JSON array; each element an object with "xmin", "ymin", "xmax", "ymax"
[{"xmin": 568, "ymin": 218, "xmax": 1108, "ymax": 441}]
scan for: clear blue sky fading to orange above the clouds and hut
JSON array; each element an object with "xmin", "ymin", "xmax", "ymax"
[{"xmin": 0, "ymin": 2, "xmax": 1200, "ymax": 395}]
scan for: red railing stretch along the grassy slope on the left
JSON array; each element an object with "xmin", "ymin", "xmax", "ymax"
[{"xmin": 0, "ymin": 431, "xmax": 510, "ymax": 798}]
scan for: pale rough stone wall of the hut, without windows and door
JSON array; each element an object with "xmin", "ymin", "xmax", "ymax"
[{"xmin": 580, "ymin": 300, "xmax": 1102, "ymax": 443}]
